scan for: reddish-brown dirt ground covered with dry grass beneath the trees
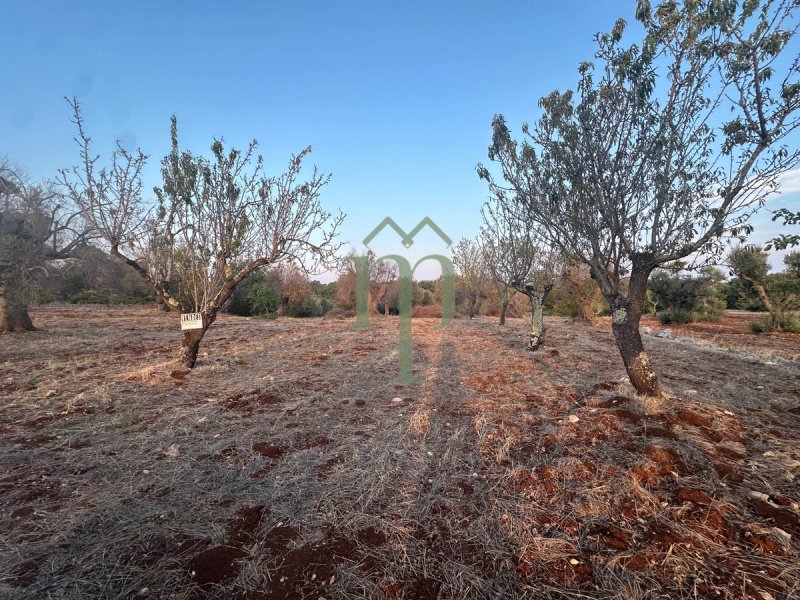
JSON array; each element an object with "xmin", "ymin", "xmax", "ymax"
[{"xmin": 0, "ymin": 306, "xmax": 800, "ymax": 600}]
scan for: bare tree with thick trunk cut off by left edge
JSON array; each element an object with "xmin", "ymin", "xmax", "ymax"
[{"xmin": 0, "ymin": 160, "xmax": 87, "ymax": 332}]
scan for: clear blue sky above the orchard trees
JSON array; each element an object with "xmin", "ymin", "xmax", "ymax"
[{"xmin": 0, "ymin": 0, "xmax": 800, "ymax": 278}]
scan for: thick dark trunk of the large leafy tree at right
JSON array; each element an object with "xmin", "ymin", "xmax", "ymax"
[{"xmin": 606, "ymin": 262, "xmax": 661, "ymax": 396}]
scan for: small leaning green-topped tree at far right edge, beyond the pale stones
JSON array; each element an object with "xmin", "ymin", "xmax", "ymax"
[{"xmin": 728, "ymin": 246, "xmax": 800, "ymax": 331}]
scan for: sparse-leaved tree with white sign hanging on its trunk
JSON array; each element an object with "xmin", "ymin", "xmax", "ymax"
[{"xmin": 62, "ymin": 102, "xmax": 344, "ymax": 369}]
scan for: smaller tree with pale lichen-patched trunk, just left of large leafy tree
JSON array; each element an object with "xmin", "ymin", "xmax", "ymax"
[{"xmin": 481, "ymin": 190, "xmax": 558, "ymax": 352}]
